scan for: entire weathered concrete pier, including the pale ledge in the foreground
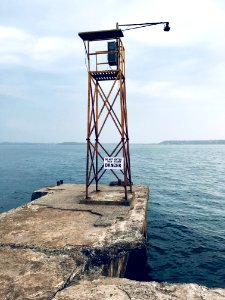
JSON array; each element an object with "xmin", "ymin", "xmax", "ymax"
[{"xmin": 0, "ymin": 184, "xmax": 225, "ymax": 300}]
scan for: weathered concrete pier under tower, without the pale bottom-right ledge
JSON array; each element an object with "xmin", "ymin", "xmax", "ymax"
[{"xmin": 0, "ymin": 184, "xmax": 148, "ymax": 300}]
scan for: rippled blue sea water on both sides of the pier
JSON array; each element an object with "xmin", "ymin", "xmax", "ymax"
[{"xmin": 0, "ymin": 144, "xmax": 225, "ymax": 287}]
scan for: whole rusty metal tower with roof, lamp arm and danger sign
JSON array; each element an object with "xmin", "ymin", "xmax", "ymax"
[{"xmin": 78, "ymin": 22, "xmax": 170, "ymax": 200}]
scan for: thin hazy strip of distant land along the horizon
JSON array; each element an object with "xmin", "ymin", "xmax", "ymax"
[{"xmin": 0, "ymin": 140, "xmax": 225, "ymax": 146}]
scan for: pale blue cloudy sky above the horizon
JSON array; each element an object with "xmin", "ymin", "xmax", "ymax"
[{"xmin": 0, "ymin": 0, "xmax": 225, "ymax": 143}]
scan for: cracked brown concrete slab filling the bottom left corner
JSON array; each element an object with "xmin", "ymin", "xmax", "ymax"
[{"xmin": 0, "ymin": 248, "xmax": 79, "ymax": 300}]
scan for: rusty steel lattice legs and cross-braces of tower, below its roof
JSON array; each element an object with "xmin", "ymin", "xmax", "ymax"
[{"xmin": 86, "ymin": 38, "xmax": 132, "ymax": 199}]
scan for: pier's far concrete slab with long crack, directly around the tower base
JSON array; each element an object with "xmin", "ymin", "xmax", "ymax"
[{"xmin": 0, "ymin": 184, "xmax": 148, "ymax": 250}]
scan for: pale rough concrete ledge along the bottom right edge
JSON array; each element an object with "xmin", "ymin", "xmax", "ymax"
[{"xmin": 53, "ymin": 278, "xmax": 225, "ymax": 300}]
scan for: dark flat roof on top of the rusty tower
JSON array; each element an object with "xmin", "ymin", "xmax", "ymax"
[{"xmin": 78, "ymin": 29, "xmax": 123, "ymax": 41}]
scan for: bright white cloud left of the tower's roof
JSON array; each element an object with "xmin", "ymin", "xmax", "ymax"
[{"xmin": 0, "ymin": 26, "xmax": 83, "ymax": 68}]
